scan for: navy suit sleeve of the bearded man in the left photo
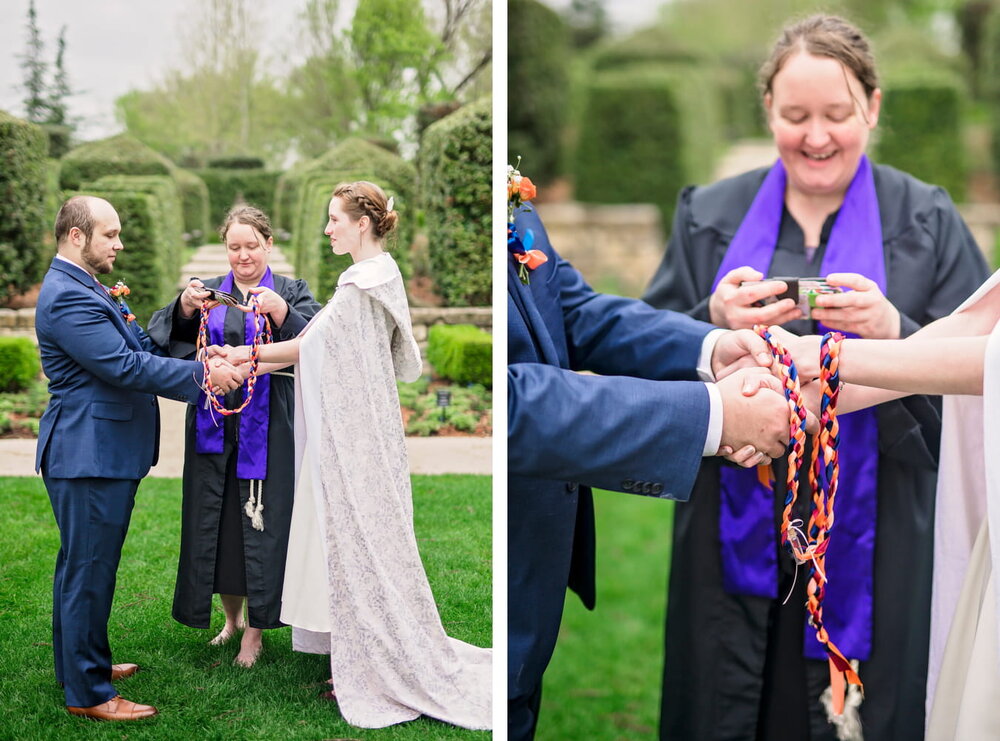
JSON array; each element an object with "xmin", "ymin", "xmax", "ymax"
[{"xmin": 51, "ymin": 300, "xmax": 203, "ymax": 404}]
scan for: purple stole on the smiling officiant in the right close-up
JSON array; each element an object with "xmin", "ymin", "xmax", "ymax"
[{"xmin": 712, "ymin": 156, "xmax": 885, "ymax": 660}]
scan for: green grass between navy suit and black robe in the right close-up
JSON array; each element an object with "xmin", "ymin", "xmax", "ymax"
[{"xmin": 537, "ymin": 491, "xmax": 674, "ymax": 741}]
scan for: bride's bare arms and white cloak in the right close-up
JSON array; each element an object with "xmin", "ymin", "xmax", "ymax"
[{"xmin": 772, "ymin": 271, "xmax": 1000, "ymax": 741}]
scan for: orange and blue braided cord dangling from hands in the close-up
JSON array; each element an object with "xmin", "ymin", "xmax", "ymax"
[{"xmin": 754, "ymin": 325, "xmax": 864, "ymax": 715}]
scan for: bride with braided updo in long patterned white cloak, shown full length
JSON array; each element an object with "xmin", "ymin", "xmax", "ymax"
[{"xmin": 229, "ymin": 181, "xmax": 492, "ymax": 730}]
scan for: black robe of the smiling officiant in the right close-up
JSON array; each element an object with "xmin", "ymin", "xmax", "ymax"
[{"xmin": 643, "ymin": 165, "xmax": 989, "ymax": 741}]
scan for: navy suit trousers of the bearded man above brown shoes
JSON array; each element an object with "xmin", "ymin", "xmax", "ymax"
[{"xmin": 43, "ymin": 475, "xmax": 139, "ymax": 707}]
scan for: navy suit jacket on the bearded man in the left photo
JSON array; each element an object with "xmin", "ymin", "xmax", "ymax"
[{"xmin": 35, "ymin": 258, "xmax": 203, "ymax": 479}]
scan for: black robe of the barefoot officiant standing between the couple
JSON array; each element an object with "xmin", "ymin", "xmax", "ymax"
[{"xmin": 148, "ymin": 205, "xmax": 320, "ymax": 663}]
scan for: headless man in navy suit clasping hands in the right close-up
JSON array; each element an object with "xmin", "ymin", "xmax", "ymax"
[{"xmin": 507, "ymin": 207, "xmax": 789, "ymax": 741}]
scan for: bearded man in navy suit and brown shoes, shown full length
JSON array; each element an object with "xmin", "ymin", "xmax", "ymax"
[{"xmin": 35, "ymin": 196, "xmax": 243, "ymax": 720}]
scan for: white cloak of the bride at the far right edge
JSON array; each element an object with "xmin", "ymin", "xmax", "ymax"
[{"xmin": 924, "ymin": 272, "xmax": 1000, "ymax": 741}]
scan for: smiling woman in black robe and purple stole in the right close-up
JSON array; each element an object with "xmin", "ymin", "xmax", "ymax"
[{"xmin": 643, "ymin": 16, "xmax": 989, "ymax": 741}]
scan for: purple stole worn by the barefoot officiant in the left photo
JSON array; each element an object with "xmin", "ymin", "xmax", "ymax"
[{"xmin": 195, "ymin": 268, "xmax": 274, "ymax": 481}]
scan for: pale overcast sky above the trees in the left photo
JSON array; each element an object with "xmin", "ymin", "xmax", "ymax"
[{"xmin": 0, "ymin": 0, "xmax": 354, "ymax": 140}]
